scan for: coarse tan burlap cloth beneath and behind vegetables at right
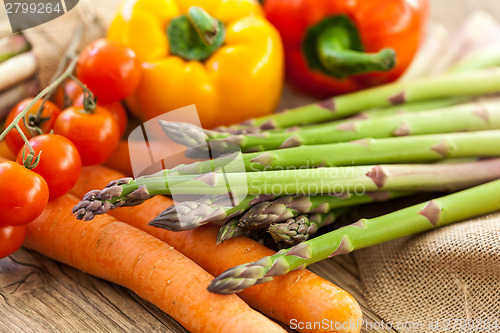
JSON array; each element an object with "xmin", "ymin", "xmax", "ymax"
[{"xmin": 355, "ymin": 0, "xmax": 500, "ymax": 332}]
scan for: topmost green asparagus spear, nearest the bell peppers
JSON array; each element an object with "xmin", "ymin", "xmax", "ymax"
[{"xmin": 163, "ymin": 69, "xmax": 500, "ymax": 136}]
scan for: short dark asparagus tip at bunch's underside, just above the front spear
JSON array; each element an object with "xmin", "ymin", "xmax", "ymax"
[{"xmin": 267, "ymin": 207, "xmax": 351, "ymax": 245}]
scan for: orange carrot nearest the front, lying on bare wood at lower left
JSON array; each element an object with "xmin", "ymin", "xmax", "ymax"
[{"xmin": 24, "ymin": 194, "xmax": 285, "ymax": 333}]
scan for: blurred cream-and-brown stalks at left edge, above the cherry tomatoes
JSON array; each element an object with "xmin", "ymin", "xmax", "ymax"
[{"xmin": 0, "ymin": 35, "xmax": 38, "ymax": 121}]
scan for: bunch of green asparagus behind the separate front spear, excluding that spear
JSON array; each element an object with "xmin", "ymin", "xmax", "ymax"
[{"xmin": 74, "ymin": 48, "xmax": 500, "ymax": 252}]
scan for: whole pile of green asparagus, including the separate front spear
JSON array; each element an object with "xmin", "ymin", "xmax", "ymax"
[{"xmin": 73, "ymin": 62, "xmax": 500, "ymax": 293}]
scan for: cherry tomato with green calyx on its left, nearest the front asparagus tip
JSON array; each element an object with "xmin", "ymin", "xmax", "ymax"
[{"xmin": 17, "ymin": 134, "xmax": 82, "ymax": 200}]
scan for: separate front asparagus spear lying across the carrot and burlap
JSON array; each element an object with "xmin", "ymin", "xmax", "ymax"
[{"xmin": 208, "ymin": 180, "xmax": 500, "ymax": 294}]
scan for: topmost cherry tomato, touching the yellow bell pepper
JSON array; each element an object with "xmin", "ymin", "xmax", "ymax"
[{"xmin": 76, "ymin": 38, "xmax": 142, "ymax": 104}]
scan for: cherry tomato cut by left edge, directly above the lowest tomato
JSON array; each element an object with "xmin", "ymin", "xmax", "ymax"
[{"xmin": 0, "ymin": 161, "xmax": 49, "ymax": 227}]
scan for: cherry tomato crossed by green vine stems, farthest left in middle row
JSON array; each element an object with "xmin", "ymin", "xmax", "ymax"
[{"xmin": 5, "ymin": 98, "xmax": 61, "ymax": 154}]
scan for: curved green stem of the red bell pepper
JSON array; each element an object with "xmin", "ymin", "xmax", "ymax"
[{"xmin": 303, "ymin": 15, "xmax": 396, "ymax": 79}]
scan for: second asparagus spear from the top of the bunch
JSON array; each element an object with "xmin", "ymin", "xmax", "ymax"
[{"xmin": 165, "ymin": 100, "xmax": 500, "ymax": 152}]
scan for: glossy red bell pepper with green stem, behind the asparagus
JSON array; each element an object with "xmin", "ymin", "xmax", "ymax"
[{"xmin": 264, "ymin": 0, "xmax": 429, "ymax": 97}]
